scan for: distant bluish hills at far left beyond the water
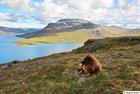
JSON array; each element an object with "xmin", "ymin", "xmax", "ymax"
[{"xmin": 0, "ymin": 26, "xmax": 38, "ymax": 34}]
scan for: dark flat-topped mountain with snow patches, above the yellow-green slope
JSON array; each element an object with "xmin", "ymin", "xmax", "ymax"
[{"xmin": 19, "ymin": 19, "xmax": 99, "ymax": 38}]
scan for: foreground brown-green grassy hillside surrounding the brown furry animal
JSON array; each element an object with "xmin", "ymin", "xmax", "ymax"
[{"xmin": 0, "ymin": 37, "xmax": 140, "ymax": 94}]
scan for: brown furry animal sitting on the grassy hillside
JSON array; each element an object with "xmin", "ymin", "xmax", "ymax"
[{"xmin": 78, "ymin": 54, "xmax": 102, "ymax": 75}]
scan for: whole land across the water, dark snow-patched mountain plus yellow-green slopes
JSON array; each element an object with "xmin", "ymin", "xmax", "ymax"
[{"xmin": 16, "ymin": 19, "xmax": 140, "ymax": 45}]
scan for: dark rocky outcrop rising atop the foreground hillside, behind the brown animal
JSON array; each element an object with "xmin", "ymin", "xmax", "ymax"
[{"xmin": 73, "ymin": 36, "xmax": 140, "ymax": 53}]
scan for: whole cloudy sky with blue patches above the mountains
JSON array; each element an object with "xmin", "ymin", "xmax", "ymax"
[{"xmin": 0, "ymin": 0, "xmax": 140, "ymax": 28}]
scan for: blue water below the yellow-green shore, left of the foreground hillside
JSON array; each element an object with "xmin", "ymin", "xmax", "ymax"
[{"xmin": 0, "ymin": 35, "xmax": 83, "ymax": 64}]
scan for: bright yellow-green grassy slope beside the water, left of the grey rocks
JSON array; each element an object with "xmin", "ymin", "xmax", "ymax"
[{"xmin": 16, "ymin": 29, "xmax": 96, "ymax": 45}]
